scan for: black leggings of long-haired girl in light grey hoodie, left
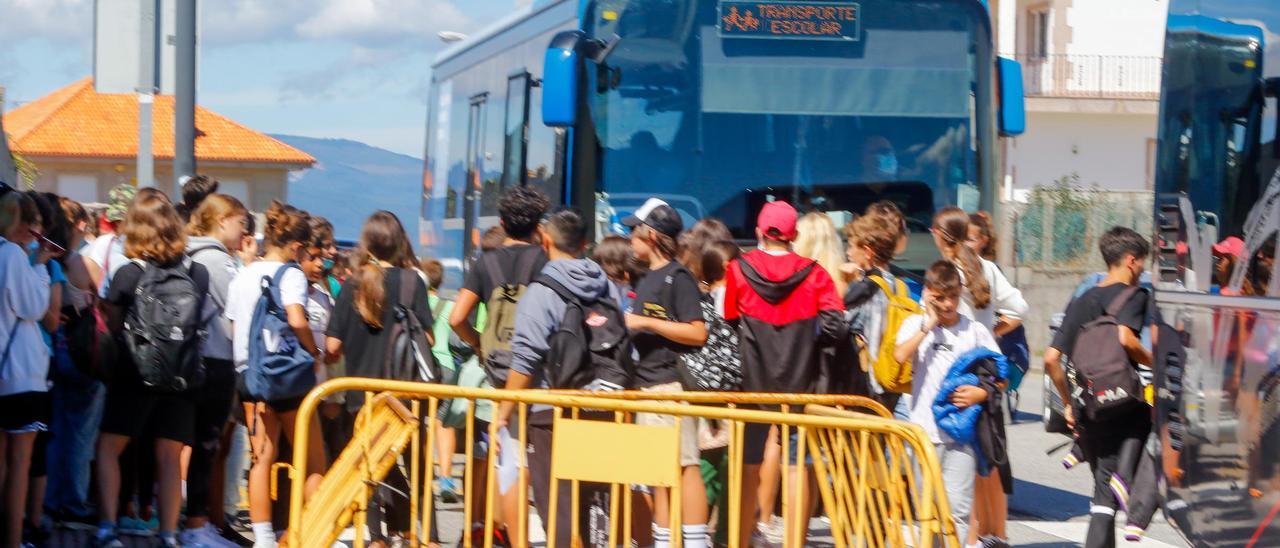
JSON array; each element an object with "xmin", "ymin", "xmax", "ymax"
[{"xmin": 187, "ymin": 359, "xmax": 236, "ymax": 517}]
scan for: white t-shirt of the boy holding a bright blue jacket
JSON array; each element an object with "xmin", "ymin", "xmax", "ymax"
[{"xmin": 896, "ymin": 315, "xmax": 1000, "ymax": 443}]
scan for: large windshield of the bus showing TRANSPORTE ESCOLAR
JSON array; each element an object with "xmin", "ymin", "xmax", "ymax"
[{"xmin": 582, "ymin": 0, "xmax": 991, "ymax": 244}]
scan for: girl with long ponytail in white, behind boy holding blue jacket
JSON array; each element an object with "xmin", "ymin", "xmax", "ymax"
[{"xmin": 931, "ymin": 207, "xmax": 1027, "ymax": 544}]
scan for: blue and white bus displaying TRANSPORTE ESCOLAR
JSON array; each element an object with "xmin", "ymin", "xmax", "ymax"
[{"xmin": 419, "ymin": 0, "xmax": 1025, "ymax": 287}]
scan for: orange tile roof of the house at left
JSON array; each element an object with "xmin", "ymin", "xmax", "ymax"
[{"xmin": 4, "ymin": 78, "xmax": 316, "ymax": 168}]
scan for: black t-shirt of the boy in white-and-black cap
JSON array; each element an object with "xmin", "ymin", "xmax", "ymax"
[{"xmin": 631, "ymin": 261, "xmax": 703, "ymax": 388}]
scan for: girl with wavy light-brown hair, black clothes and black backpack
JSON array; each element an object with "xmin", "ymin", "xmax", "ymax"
[{"xmin": 97, "ymin": 195, "xmax": 209, "ymax": 545}]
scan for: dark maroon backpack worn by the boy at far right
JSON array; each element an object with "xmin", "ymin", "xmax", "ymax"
[{"xmin": 1070, "ymin": 287, "xmax": 1144, "ymax": 421}]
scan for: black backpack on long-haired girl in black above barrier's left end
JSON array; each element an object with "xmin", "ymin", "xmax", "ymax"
[{"xmin": 383, "ymin": 269, "xmax": 440, "ymax": 383}]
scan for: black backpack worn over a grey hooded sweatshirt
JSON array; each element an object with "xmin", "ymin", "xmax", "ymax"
[{"xmin": 534, "ymin": 275, "xmax": 635, "ymax": 389}]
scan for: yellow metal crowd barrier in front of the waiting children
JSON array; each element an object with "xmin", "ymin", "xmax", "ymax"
[{"xmin": 287, "ymin": 378, "xmax": 960, "ymax": 548}]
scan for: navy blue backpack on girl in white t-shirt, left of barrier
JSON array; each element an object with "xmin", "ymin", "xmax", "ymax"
[{"xmin": 244, "ymin": 262, "xmax": 316, "ymax": 402}]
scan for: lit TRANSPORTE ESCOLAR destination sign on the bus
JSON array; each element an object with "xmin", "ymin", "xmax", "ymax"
[{"xmin": 718, "ymin": 0, "xmax": 861, "ymax": 41}]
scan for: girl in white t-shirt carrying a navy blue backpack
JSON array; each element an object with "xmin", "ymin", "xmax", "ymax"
[{"xmin": 225, "ymin": 202, "xmax": 325, "ymax": 547}]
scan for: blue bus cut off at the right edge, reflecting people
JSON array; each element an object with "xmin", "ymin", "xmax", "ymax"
[{"xmin": 1153, "ymin": 0, "xmax": 1280, "ymax": 547}]
